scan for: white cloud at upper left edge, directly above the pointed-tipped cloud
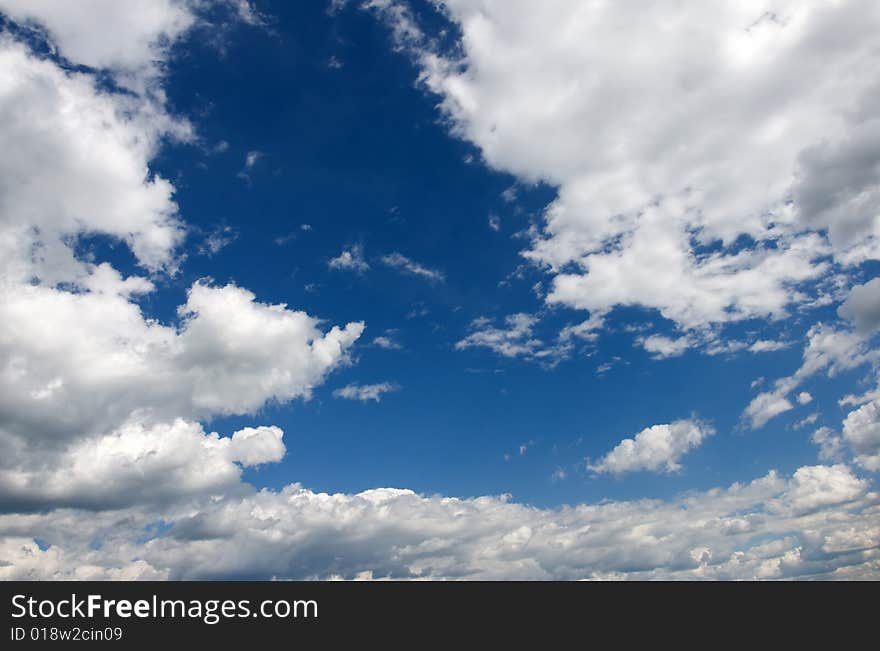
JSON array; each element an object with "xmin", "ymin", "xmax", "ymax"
[{"xmin": 0, "ymin": 39, "xmax": 190, "ymax": 283}]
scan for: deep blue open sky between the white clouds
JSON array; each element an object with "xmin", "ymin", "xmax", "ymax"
[{"xmin": 148, "ymin": 4, "xmax": 864, "ymax": 505}]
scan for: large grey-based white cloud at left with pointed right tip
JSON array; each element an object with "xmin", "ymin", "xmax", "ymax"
[{"xmin": 0, "ymin": 284, "xmax": 363, "ymax": 509}]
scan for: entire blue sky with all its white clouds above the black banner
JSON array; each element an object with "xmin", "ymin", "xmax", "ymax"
[{"xmin": 0, "ymin": 0, "xmax": 880, "ymax": 580}]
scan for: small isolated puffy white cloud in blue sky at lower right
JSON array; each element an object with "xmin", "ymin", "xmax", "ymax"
[{"xmin": 587, "ymin": 420, "xmax": 715, "ymax": 475}]
